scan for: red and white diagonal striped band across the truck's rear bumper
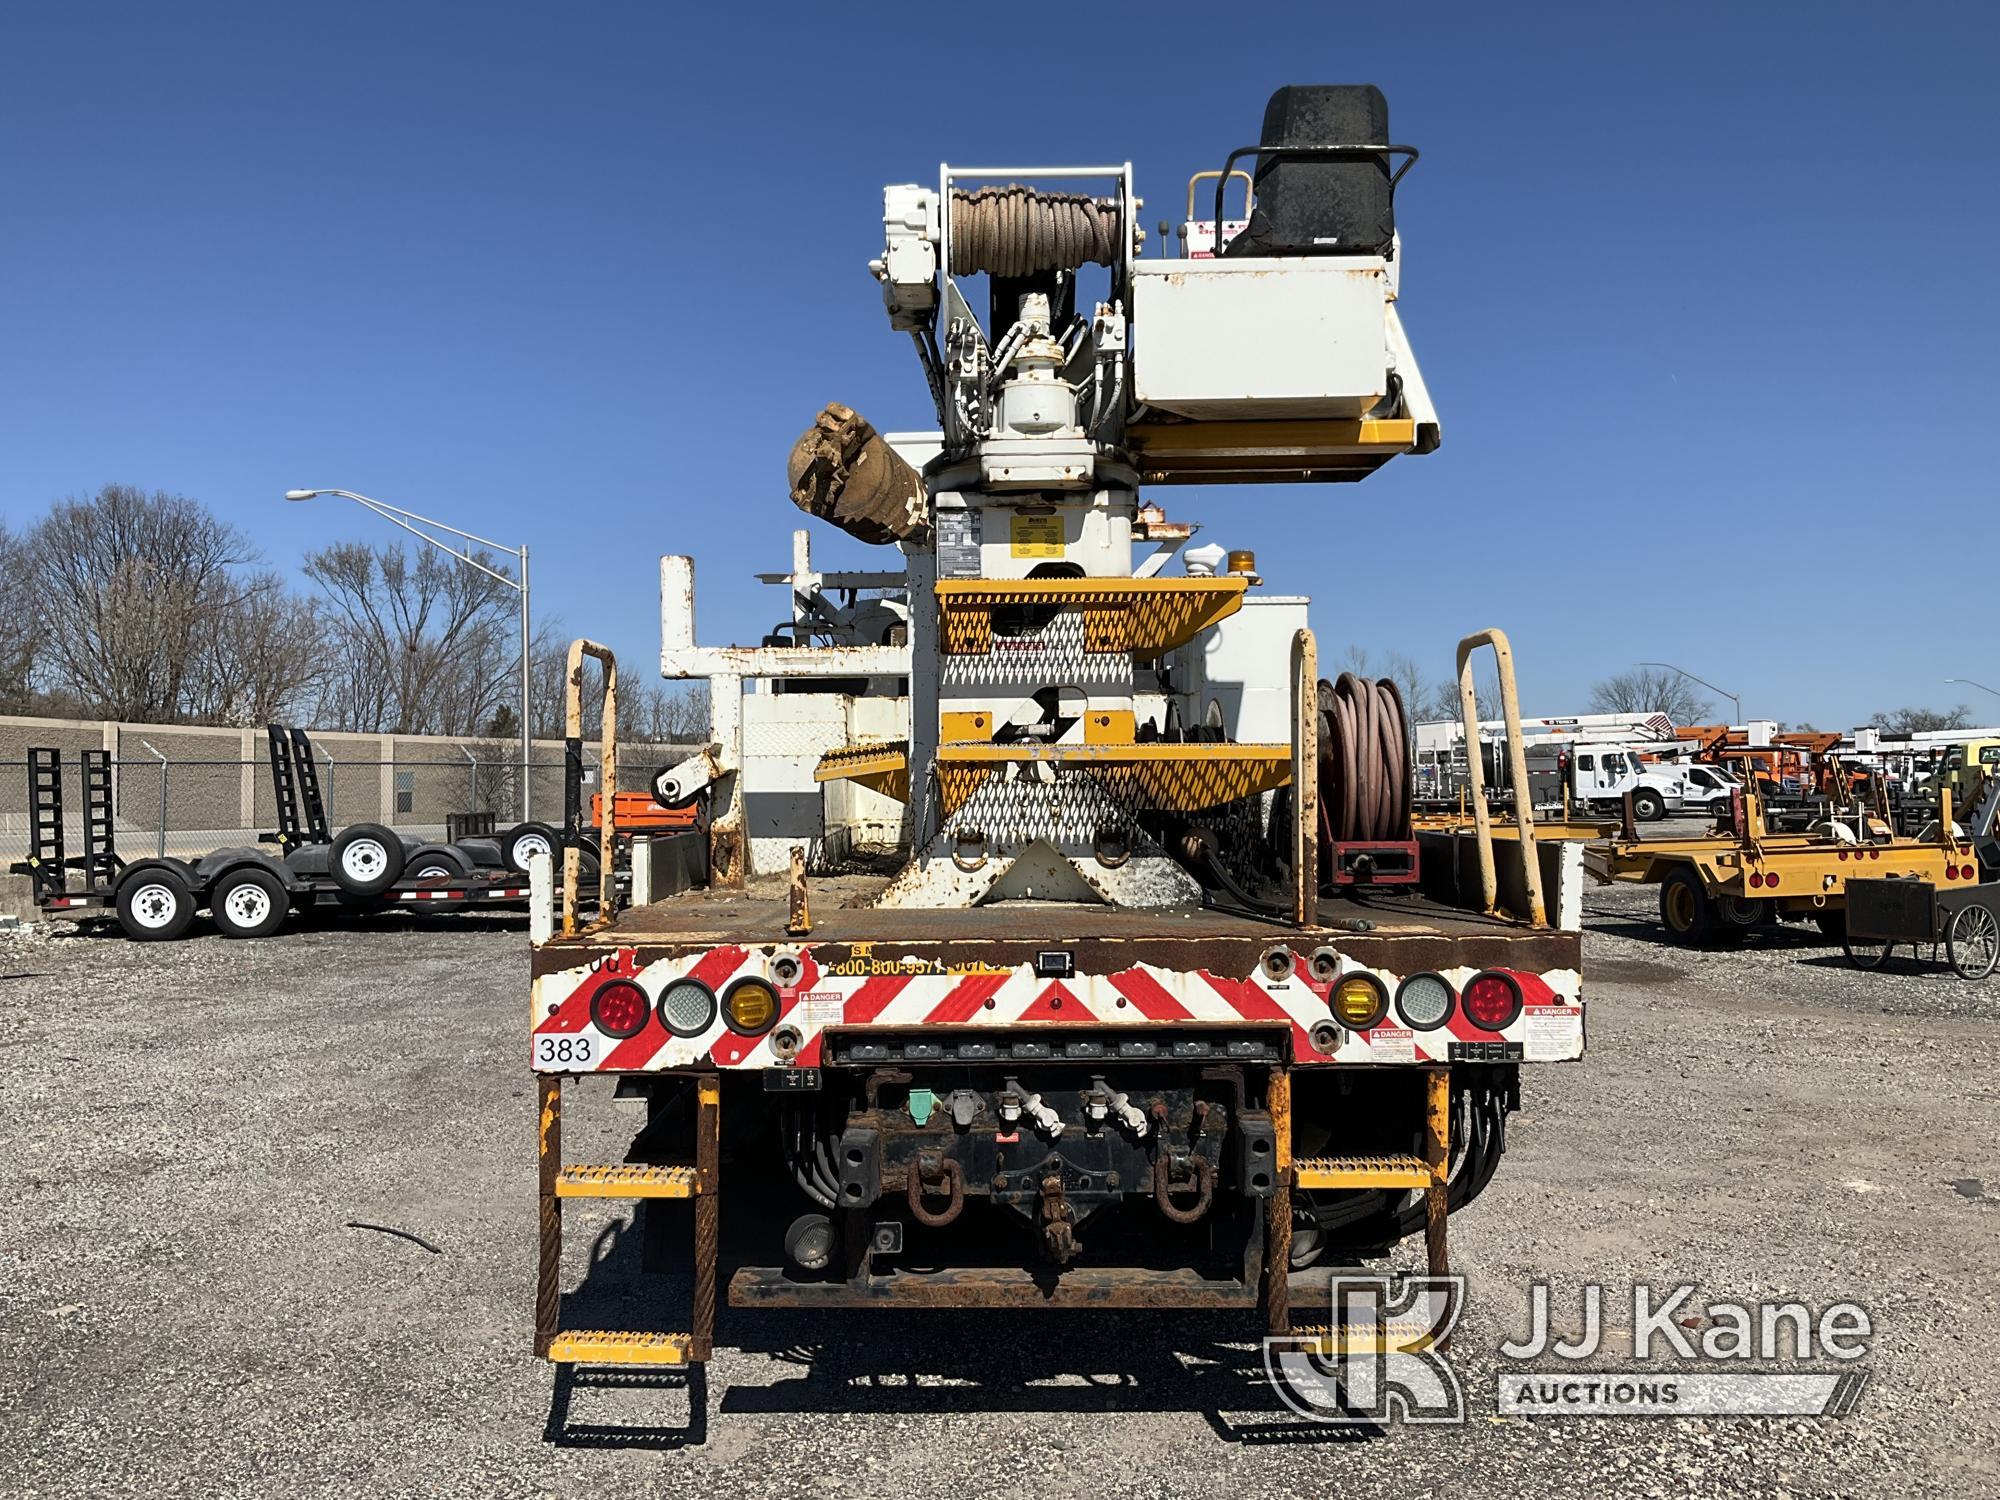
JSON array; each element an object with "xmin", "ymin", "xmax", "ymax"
[{"xmin": 530, "ymin": 946, "xmax": 1584, "ymax": 1072}]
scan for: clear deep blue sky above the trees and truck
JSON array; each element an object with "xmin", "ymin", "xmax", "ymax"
[{"xmin": 0, "ymin": 2, "xmax": 2000, "ymax": 726}]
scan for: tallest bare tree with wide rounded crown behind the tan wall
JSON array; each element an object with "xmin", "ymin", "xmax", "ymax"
[{"xmin": 22, "ymin": 484, "xmax": 282, "ymax": 720}]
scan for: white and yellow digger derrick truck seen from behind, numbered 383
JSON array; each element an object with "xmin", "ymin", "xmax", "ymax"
[{"xmin": 530, "ymin": 88, "xmax": 1584, "ymax": 1364}]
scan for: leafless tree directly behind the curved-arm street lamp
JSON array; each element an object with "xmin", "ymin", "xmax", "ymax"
[{"xmin": 306, "ymin": 542, "xmax": 520, "ymax": 734}]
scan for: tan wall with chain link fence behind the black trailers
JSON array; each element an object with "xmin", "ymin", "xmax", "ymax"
[{"xmin": 0, "ymin": 742, "xmax": 692, "ymax": 868}]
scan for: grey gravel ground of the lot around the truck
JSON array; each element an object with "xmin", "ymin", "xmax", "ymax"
[{"xmin": 0, "ymin": 888, "xmax": 2000, "ymax": 1496}]
